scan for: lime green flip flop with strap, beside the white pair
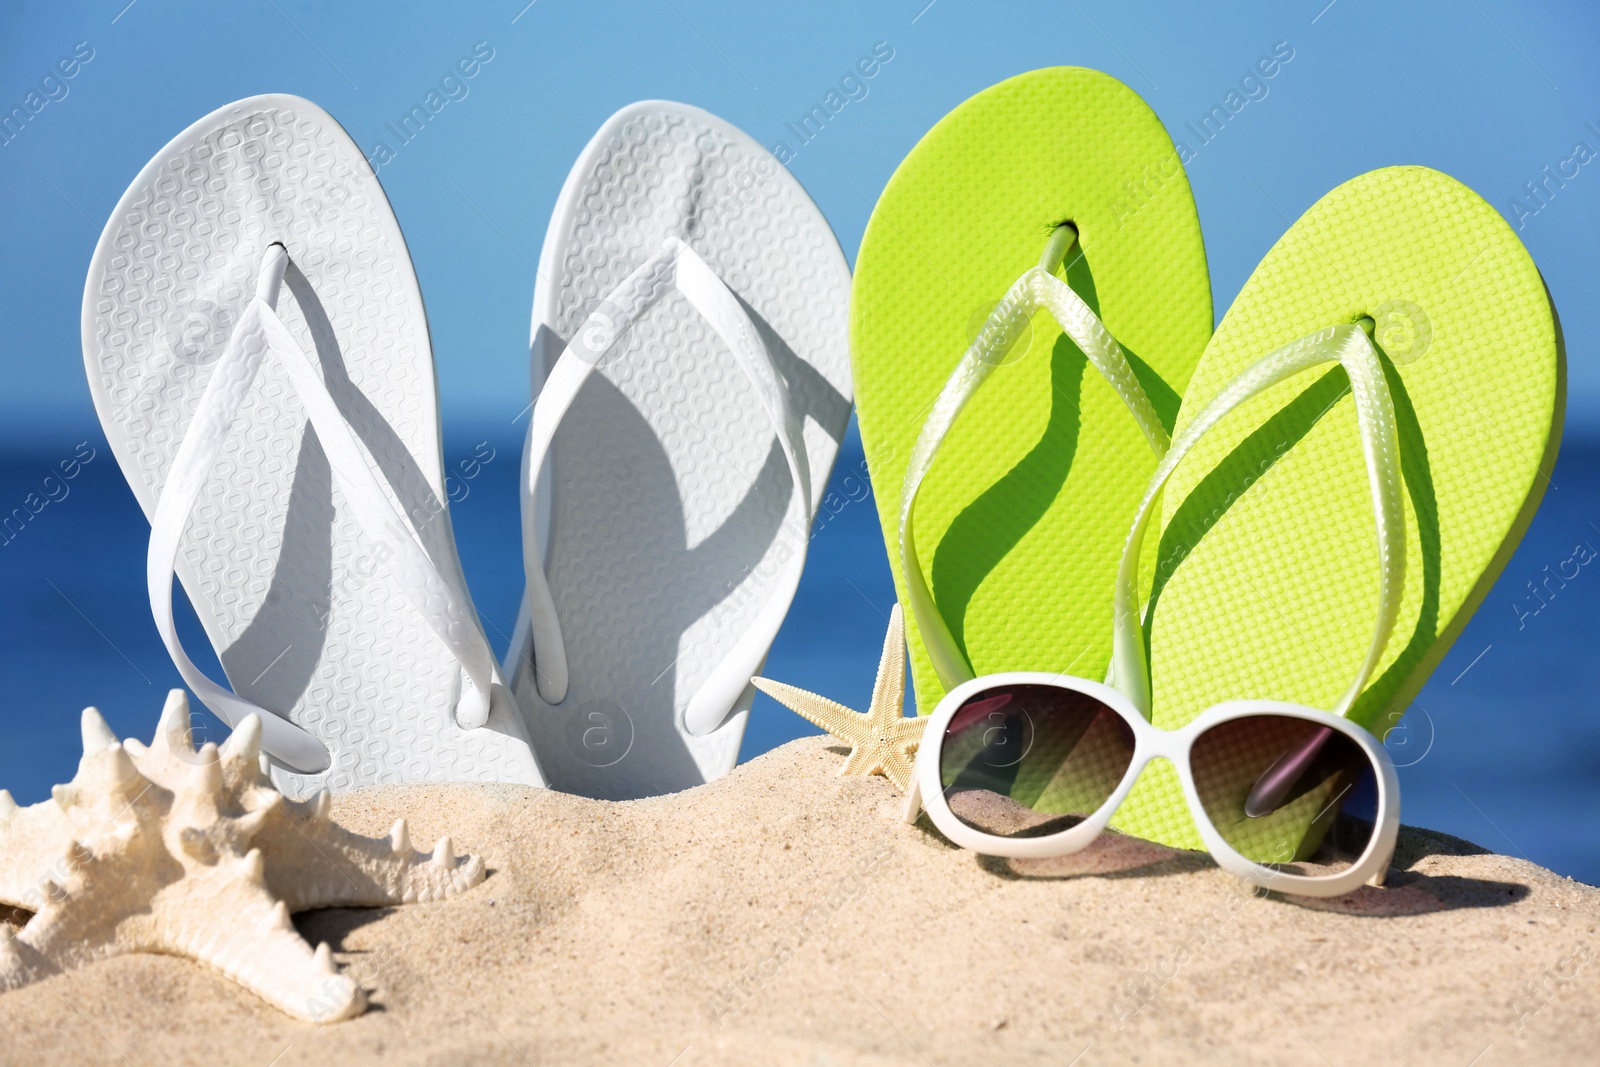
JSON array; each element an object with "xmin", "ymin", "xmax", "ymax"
[{"xmin": 850, "ymin": 67, "xmax": 1213, "ymax": 712}]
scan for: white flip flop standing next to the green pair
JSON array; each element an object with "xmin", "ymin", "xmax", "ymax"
[{"xmin": 506, "ymin": 101, "xmax": 851, "ymax": 798}]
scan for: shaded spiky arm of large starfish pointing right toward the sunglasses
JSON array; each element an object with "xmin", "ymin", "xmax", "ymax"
[{"xmin": 254, "ymin": 798, "xmax": 486, "ymax": 912}]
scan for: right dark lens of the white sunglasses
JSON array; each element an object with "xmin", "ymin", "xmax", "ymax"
[{"xmin": 1189, "ymin": 715, "xmax": 1378, "ymax": 878}]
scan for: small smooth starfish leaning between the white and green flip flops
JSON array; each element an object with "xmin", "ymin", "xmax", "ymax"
[{"xmin": 750, "ymin": 605, "xmax": 928, "ymax": 792}]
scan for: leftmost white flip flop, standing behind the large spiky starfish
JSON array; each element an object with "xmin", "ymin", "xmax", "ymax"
[{"xmin": 83, "ymin": 96, "xmax": 544, "ymax": 795}]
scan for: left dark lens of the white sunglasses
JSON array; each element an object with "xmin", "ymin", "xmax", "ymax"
[{"xmin": 939, "ymin": 685, "xmax": 1133, "ymax": 837}]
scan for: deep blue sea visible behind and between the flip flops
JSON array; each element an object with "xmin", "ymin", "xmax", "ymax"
[{"xmin": 0, "ymin": 430, "xmax": 1600, "ymax": 885}]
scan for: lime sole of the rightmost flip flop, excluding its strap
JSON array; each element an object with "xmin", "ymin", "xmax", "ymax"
[{"xmin": 1112, "ymin": 166, "xmax": 1566, "ymax": 848}]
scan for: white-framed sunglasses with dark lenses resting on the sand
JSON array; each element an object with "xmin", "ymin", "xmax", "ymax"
[{"xmin": 907, "ymin": 672, "xmax": 1400, "ymax": 896}]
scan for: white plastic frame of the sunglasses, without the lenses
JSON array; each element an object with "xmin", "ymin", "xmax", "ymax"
[{"xmin": 906, "ymin": 672, "xmax": 1400, "ymax": 897}]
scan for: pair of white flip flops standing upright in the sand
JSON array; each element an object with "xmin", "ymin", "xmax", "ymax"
[{"xmin": 83, "ymin": 96, "xmax": 851, "ymax": 798}]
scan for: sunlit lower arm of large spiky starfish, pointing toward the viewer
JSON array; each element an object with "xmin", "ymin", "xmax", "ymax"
[{"xmin": 150, "ymin": 853, "xmax": 366, "ymax": 1022}]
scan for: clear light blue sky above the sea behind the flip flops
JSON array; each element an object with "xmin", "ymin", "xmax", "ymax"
[{"xmin": 0, "ymin": 0, "xmax": 1600, "ymax": 440}]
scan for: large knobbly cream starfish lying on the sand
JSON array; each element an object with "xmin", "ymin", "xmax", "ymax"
[{"xmin": 0, "ymin": 689, "xmax": 485, "ymax": 1022}]
